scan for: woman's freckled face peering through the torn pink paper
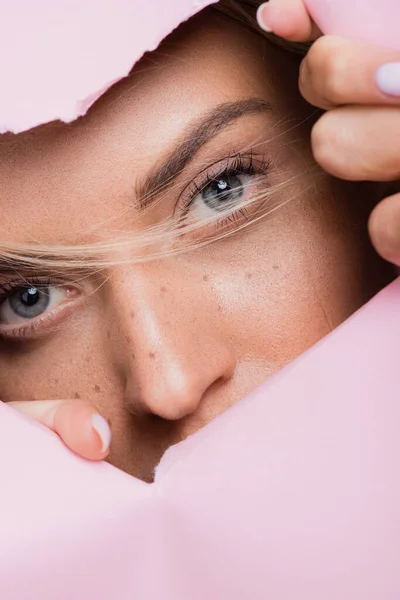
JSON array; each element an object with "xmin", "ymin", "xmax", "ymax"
[{"xmin": 0, "ymin": 10, "xmax": 385, "ymax": 480}]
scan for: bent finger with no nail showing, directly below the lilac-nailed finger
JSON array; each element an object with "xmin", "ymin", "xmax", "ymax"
[{"xmin": 311, "ymin": 106, "xmax": 400, "ymax": 181}]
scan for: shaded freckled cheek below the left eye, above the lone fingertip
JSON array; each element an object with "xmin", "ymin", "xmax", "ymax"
[{"xmin": 0, "ymin": 311, "xmax": 119, "ymax": 409}]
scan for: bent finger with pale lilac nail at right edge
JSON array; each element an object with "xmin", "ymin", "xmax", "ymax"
[{"xmin": 299, "ymin": 36, "xmax": 400, "ymax": 109}]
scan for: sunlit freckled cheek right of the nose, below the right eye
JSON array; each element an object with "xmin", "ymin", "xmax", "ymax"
[{"xmin": 203, "ymin": 190, "xmax": 364, "ymax": 370}]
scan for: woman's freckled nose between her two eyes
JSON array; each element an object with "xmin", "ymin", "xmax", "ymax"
[{"xmin": 108, "ymin": 264, "xmax": 236, "ymax": 420}]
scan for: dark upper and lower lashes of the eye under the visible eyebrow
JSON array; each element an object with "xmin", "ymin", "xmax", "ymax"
[{"xmin": 177, "ymin": 152, "xmax": 270, "ymax": 229}]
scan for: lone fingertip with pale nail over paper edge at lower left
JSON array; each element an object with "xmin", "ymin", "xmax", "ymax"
[{"xmin": 9, "ymin": 400, "xmax": 111, "ymax": 460}]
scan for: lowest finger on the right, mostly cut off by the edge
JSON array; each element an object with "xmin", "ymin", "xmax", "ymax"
[{"xmin": 368, "ymin": 194, "xmax": 400, "ymax": 266}]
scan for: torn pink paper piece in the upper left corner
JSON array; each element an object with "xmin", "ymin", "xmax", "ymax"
[{"xmin": 0, "ymin": 0, "xmax": 216, "ymax": 133}]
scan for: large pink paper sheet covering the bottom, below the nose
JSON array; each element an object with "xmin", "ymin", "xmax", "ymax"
[{"xmin": 0, "ymin": 280, "xmax": 400, "ymax": 600}]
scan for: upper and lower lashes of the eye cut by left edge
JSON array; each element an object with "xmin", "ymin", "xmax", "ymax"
[{"xmin": 0, "ymin": 277, "xmax": 78, "ymax": 341}]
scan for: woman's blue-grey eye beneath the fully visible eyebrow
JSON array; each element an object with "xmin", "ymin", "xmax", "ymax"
[{"xmin": 179, "ymin": 154, "xmax": 269, "ymax": 239}]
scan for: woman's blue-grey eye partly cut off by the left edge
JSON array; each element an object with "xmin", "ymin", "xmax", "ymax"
[{"xmin": 0, "ymin": 279, "xmax": 79, "ymax": 340}]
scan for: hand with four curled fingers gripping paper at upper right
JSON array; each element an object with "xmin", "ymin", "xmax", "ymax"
[{"xmin": 258, "ymin": 0, "xmax": 400, "ymax": 265}]
